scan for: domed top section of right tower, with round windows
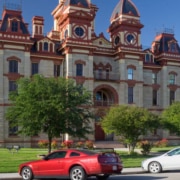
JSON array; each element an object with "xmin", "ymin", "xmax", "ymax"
[{"xmin": 108, "ymin": 0, "xmax": 143, "ymax": 49}]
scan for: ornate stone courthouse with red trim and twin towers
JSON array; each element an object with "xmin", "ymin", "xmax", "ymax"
[{"xmin": 0, "ymin": 0, "xmax": 180, "ymax": 147}]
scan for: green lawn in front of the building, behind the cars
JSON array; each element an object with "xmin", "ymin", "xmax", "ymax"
[{"xmin": 0, "ymin": 147, "xmax": 172, "ymax": 173}]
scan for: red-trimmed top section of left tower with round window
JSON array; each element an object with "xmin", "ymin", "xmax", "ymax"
[{"xmin": 52, "ymin": 0, "xmax": 97, "ymax": 46}]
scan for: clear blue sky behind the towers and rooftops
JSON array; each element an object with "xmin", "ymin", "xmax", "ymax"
[{"xmin": 0, "ymin": 0, "xmax": 180, "ymax": 47}]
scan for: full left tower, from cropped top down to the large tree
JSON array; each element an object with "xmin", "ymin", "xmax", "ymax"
[{"xmin": 52, "ymin": 0, "xmax": 98, "ymax": 85}]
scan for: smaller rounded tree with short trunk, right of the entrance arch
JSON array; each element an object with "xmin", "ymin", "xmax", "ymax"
[{"xmin": 100, "ymin": 105, "xmax": 159, "ymax": 152}]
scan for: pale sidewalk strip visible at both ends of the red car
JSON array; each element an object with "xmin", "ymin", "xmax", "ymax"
[{"xmin": 0, "ymin": 167, "xmax": 144, "ymax": 180}]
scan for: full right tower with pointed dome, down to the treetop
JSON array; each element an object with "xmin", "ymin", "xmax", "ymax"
[{"xmin": 108, "ymin": 0, "xmax": 144, "ymax": 107}]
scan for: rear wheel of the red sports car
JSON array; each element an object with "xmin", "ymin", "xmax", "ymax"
[{"xmin": 70, "ymin": 166, "xmax": 87, "ymax": 180}]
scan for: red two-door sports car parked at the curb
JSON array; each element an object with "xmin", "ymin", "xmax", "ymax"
[{"xmin": 19, "ymin": 149, "xmax": 123, "ymax": 180}]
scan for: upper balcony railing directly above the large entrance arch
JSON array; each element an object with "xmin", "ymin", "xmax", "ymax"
[{"xmin": 94, "ymin": 71, "xmax": 120, "ymax": 81}]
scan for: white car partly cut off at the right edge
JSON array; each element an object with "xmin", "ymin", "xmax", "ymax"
[{"xmin": 141, "ymin": 147, "xmax": 180, "ymax": 173}]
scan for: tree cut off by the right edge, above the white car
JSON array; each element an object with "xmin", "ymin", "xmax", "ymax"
[{"xmin": 162, "ymin": 102, "xmax": 180, "ymax": 135}]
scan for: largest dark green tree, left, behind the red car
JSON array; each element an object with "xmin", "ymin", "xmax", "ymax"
[{"xmin": 6, "ymin": 75, "xmax": 92, "ymax": 152}]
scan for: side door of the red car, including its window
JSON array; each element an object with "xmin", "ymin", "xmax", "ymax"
[{"xmin": 38, "ymin": 151, "xmax": 67, "ymax": 176}]
